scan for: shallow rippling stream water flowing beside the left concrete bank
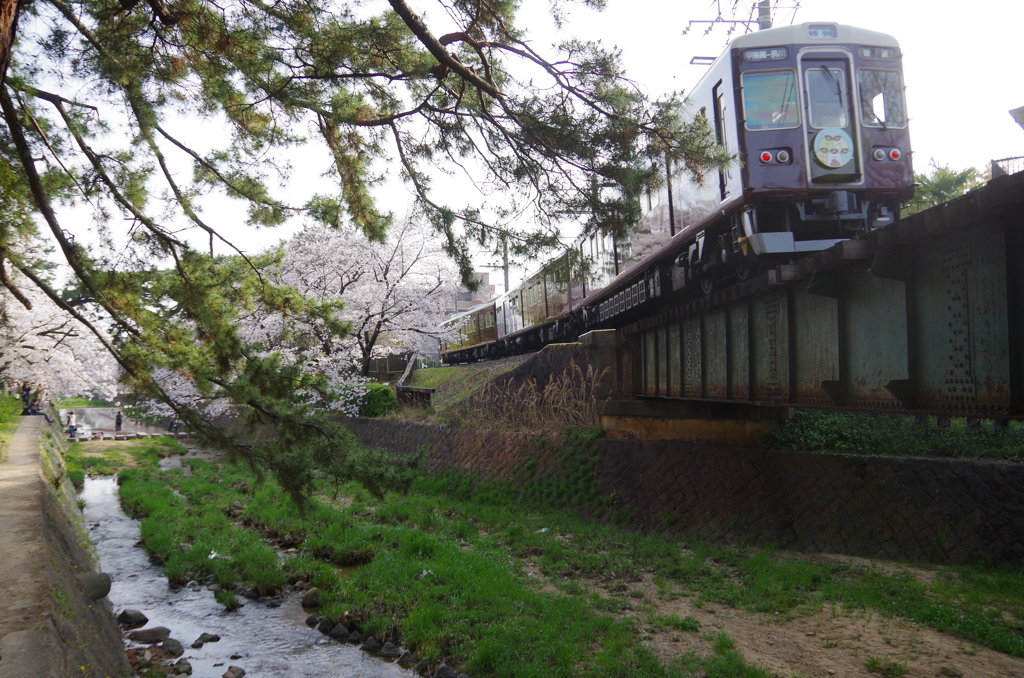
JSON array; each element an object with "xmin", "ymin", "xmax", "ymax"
[{"xmin": 81, "ymin": 477, "xmax": 415, "ymax": 678}]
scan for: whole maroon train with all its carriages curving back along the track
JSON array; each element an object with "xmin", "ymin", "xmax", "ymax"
[{"xmin": 442, "ymin": 23, "xmax": 913, "ymax": 363}]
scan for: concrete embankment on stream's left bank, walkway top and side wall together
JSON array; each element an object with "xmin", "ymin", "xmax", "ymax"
[{"xmin": 0, "ymin": 417, "xmax": 131, "ymax": 678}]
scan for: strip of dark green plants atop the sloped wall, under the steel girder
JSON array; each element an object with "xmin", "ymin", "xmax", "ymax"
[{"xmin": 766, "ymin": 410, "xmax": 1024, "ymax": 462}]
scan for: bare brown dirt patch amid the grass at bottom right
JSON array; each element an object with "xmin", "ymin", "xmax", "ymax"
[{"xmin": 552, "ymin": 561, "xmax": 1024, "ymax": 678}]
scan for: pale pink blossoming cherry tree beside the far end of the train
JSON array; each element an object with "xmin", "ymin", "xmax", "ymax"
[{"xmin": 244, "ymin": 217, "xmax": 459, "ymax": 383}]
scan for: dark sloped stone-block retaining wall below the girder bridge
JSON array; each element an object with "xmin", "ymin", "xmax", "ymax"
[{"xmin": 349, "ymin": 419, "xmax": 1024, "ymax": 566}]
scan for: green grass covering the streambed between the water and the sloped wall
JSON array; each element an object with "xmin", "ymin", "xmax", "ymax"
[{"xmin": 96, "ymin": 438, "xmax": 1024, "ymax": 678}]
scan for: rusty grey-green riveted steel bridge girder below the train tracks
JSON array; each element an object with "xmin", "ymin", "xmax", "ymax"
[{"xmin": 620, "ymin": 173, "xmax": 1024, "ymax": 419}]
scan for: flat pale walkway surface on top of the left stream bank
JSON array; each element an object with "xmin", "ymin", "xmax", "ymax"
[{"xmin": 0, "ymin": 417, "xmax": 58, "ymax": 678}]
